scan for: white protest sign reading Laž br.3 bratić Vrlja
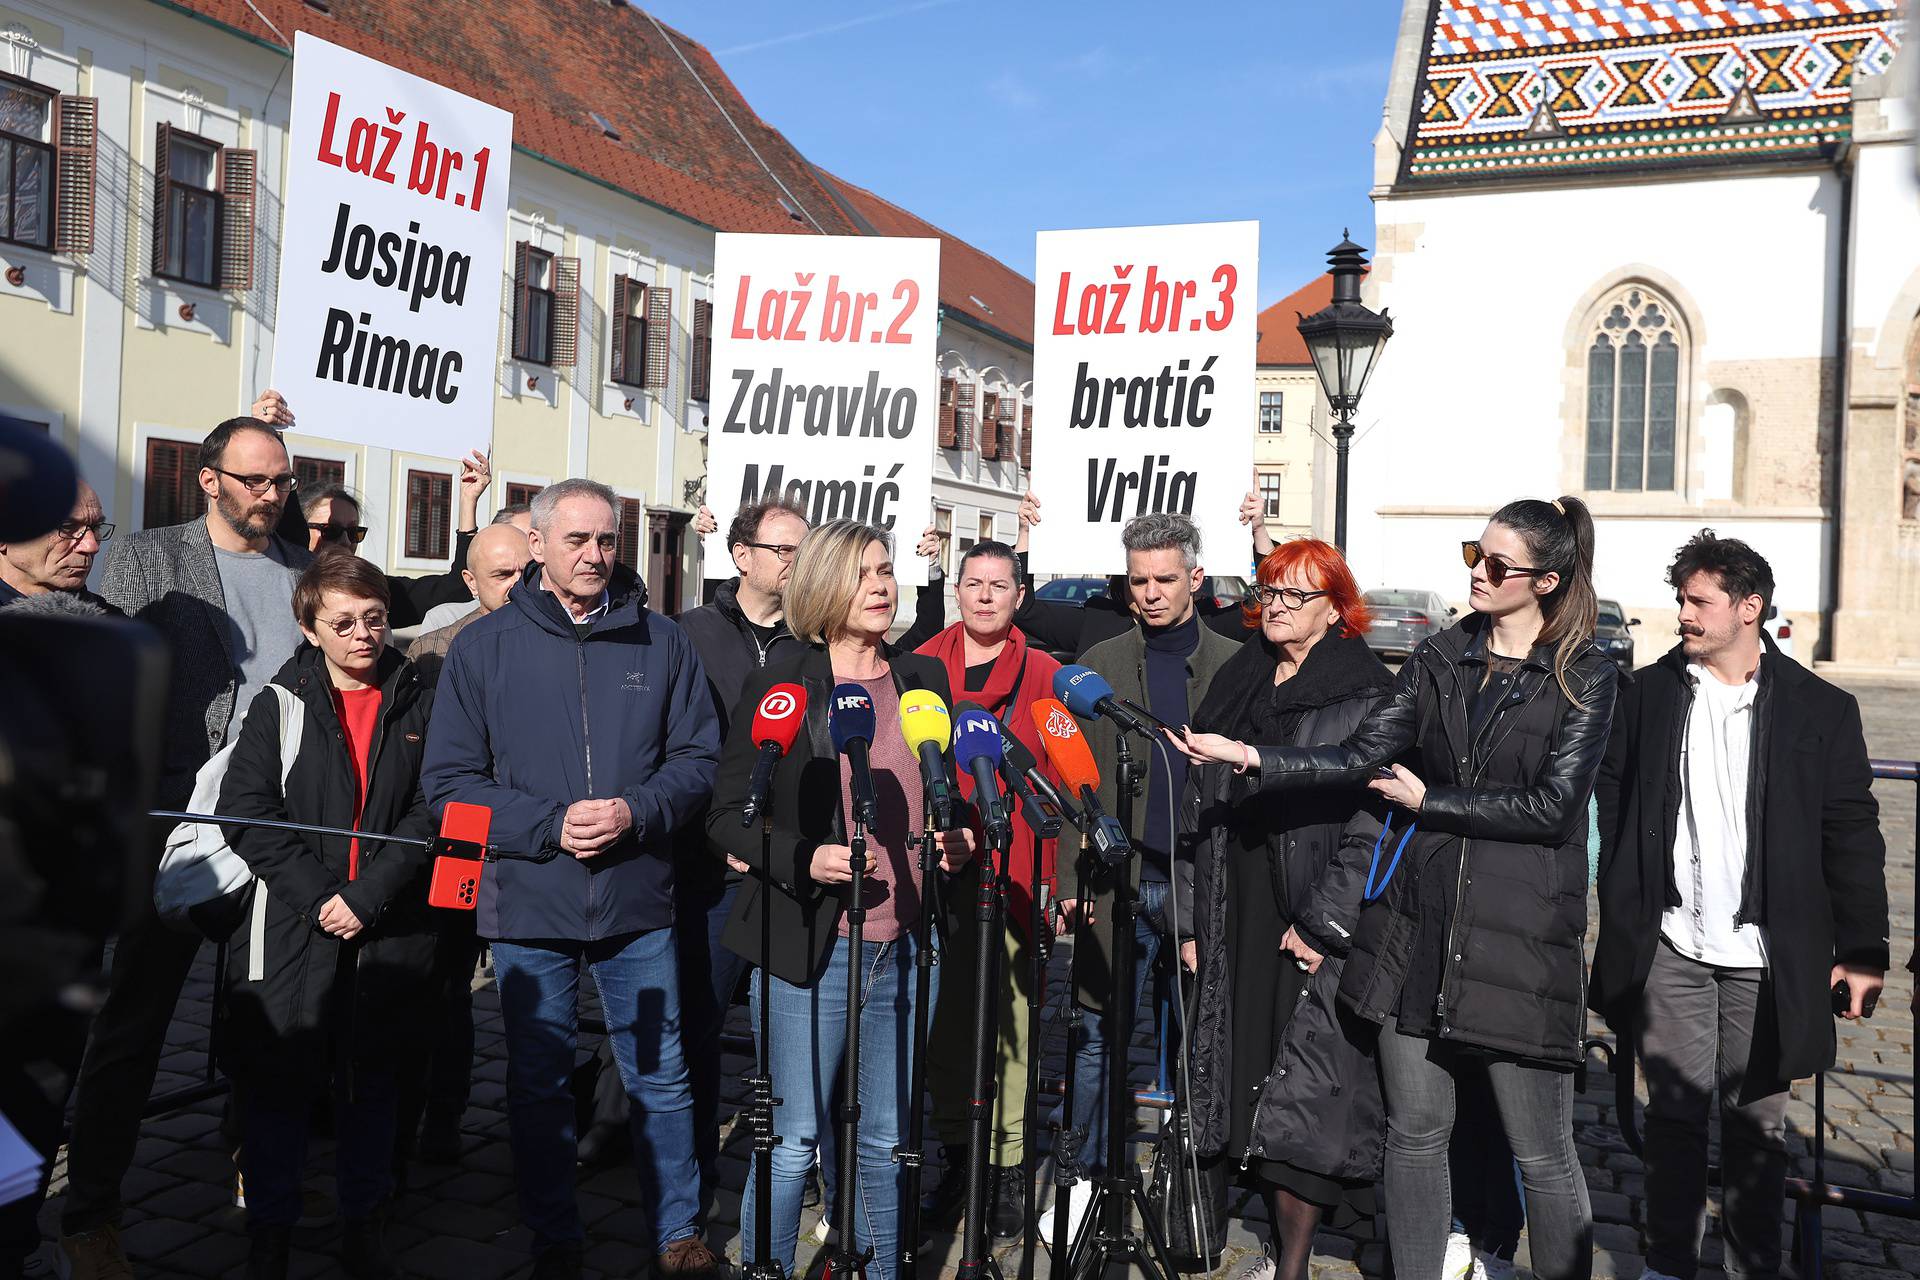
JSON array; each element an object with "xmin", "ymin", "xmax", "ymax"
[{"xmin": 1031, "ymin": 223, "xmax": 1260, "ymax": 574}]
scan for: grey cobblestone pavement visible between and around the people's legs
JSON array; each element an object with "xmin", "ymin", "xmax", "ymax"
[{"xmin": 30, "ymin": 685, "xmax": 1920, "ymax": 1280}]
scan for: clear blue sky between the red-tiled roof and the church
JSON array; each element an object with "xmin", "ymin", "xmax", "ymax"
[{"xmin": 647, "ymin": 0, "xmax": 1402, "ymax": 305}]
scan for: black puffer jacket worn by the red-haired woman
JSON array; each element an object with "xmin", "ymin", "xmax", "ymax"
[{"xmin": 1181, "ymin": 637, "xmax": 1392, "ymax": 1178}]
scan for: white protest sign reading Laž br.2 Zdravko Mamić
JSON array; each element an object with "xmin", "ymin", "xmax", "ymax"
[{"xmin": 703, "ymin": 232, "xmax": 941, "ymax": 587}]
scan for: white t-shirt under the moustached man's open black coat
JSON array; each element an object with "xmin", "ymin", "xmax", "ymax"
[{"xmin": 1661, "ymin": 662, "xmax": 1766, "ymax": 969}]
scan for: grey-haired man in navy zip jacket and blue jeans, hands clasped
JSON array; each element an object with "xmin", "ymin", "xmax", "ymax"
[{"xmin": 420, "ymin": 480, "xmax": 724, "ymax": 1280}]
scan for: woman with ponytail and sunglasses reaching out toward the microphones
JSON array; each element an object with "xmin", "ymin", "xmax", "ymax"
[{"xmin": 1181, "ymin": 497, "xmax": 1617, "ymax": 1280}]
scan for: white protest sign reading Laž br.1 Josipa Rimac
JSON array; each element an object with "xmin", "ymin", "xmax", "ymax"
[{"xmin": 273, "ymin": 31, "xmax": 513, "ymax": 459}]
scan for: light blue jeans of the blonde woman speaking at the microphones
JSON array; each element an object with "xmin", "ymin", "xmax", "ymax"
[{"xmin": 739, "ymin": 933, "xmax": 941, "ymax": 1280}]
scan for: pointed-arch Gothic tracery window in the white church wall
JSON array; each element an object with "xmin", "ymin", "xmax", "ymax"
[{"xmin": 1586, "ymin": 284, "xmax": 1684, "ymax": 493}]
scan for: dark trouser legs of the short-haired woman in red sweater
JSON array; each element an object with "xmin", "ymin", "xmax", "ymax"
[{"xmin": 240, "ymin": 1069, "xmax": 397, "ymax": 1226}]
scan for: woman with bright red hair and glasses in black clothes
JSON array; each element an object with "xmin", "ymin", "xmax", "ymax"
[{"xmin": 1181, "ymin": 537, "xmax": 1392, "ymax": 1280}]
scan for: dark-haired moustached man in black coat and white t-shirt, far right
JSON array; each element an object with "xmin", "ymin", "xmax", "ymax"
[{"xmin": 1588, "ymin": 530, "xmax": 1887, "ymax": 1280}]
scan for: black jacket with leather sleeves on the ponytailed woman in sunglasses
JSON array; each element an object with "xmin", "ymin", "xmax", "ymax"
[{"xmin": 1260, "ymin": 614, "xmax": 1619, "ymax": 1065}]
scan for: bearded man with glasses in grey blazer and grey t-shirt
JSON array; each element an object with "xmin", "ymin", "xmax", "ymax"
[{"xmin": 61, "ymin": 418, "xmax": 313, "ymax": 1280}]
